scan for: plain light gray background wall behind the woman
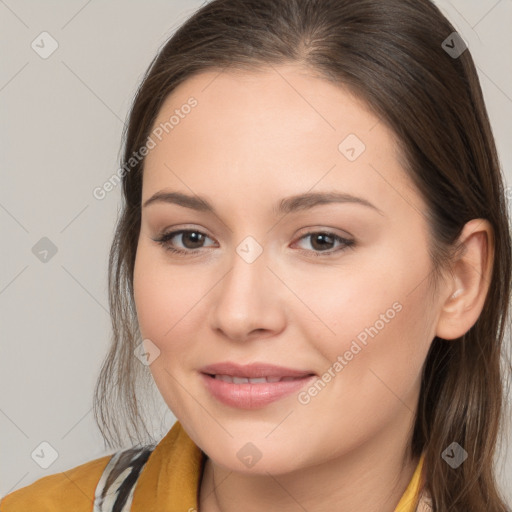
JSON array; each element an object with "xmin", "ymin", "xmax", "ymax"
[{"xmin": 0, "ymin": 0, "xmax": 512, "ymax": 503}]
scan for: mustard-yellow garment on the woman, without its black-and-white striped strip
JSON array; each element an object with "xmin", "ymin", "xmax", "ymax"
[{"xmin": 0, "ymin": 422, "xmax": 423, "ymax": 512}]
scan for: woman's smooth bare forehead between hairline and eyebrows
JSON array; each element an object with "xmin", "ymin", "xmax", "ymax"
[{"xmin": 143, "ymin": 65, "xmax": 422, "ymax": 216}]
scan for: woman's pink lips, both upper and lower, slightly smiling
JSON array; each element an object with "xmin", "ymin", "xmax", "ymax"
[{"xmin": 200, "ymin": 362, "xmax": 316, "ymax": 409}]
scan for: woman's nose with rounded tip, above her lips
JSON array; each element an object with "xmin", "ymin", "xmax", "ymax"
[{"xmin": 210, "ymin": 240, "xmax": 286, "ymax": 341}]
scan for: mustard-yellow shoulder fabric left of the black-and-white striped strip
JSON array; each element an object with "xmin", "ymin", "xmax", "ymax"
[{"xmin": 0, "ymin": 455, "xmax": 113, "ymax": 512}]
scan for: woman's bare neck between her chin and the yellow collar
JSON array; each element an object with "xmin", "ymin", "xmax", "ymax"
[{"xmin": 199, "ymin": 412, "xmax": 419, "ymax": 512}]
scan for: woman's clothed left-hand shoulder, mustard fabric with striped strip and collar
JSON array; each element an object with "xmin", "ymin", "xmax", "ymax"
[{"xmin": 0, "ymin": 422, "xmax": 198, "ymax": 512}]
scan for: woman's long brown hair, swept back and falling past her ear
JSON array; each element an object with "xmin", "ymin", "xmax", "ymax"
[{"xmin": 95, "ymin": 0, "xmax": 512, "ymax": 512}]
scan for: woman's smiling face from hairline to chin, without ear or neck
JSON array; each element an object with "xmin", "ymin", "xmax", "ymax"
[{"xmin": 134, "ymin": 65, "xmax": 439, "ymax": 474}]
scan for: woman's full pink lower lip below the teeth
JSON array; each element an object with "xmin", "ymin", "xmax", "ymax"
[{"xmin": 201, "ymin": 373, "xmax": 316, "ymax": 409}]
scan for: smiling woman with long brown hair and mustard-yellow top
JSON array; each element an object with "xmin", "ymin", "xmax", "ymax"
[{"xmin": 0, "ymin": 0, "xmax": 511, "ymax": 512}]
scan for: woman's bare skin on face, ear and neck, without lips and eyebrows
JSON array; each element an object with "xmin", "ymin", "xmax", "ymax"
[{"xmin": 134, "ymin": 64, "xmax": 492, "ymax": 512}]
